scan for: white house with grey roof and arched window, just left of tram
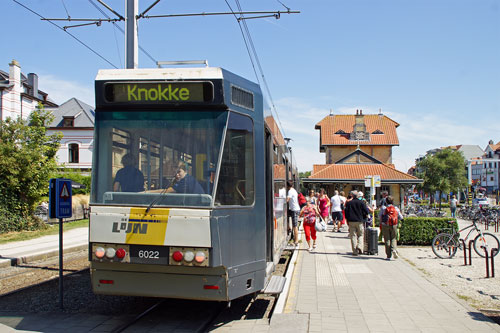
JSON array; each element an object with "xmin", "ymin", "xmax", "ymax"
[{"xmin": 47, "ymin": 98, "xmax": 95, "ymax": 172}]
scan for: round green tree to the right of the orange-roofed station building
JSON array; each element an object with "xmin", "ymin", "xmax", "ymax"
[{"xmin": 417, "ymin": 149, "xmax": 467, "ymax": 209}]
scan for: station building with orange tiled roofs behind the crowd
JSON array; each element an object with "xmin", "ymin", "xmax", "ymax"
[{"xmin": 302, "ymin": 110, "xmax": 423, "ymax": 203}]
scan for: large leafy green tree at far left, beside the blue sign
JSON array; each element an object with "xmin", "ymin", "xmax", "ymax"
[{"xmin": 0, "ymin": 104, "xmax": 62, "ymax": 218}]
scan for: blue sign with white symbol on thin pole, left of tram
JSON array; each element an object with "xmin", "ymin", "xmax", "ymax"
[{"xmin": 49, "ymin": 178, "xmax": 73, "ymax": 309}]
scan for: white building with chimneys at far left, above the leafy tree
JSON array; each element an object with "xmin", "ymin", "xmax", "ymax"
[{"xmin": 0, "ymin": 60, "xmax": 57, "ymax": 121}]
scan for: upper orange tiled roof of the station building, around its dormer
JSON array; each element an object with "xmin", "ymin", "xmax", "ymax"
[{"xmin": 315, "ymin": 114, "xmax": 399, "ymax": 146}]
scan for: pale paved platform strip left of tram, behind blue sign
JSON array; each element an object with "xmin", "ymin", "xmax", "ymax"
[{"xmin": 0, "ymin": 227, "xmax": 88, "ymax": 268}]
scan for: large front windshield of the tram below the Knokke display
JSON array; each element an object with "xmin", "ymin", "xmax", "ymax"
[{"xmin": 91, "ymin": 110, "xmax": 228, "ymax": 206}]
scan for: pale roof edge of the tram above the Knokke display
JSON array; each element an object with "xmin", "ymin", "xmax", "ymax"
[{"xmin": 96, "ymin": 67, "xmax": 224, "ymax": 81}]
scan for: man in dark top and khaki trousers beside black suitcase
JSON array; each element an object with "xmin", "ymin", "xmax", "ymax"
[{"xmin": 345, "ymin": 191, "xmax": 369, "ymax": 256}]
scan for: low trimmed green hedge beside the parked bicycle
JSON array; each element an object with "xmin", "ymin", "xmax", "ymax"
[{"xmin": 398, "ymin": 217, "xmax": 458, "ymax": 245}]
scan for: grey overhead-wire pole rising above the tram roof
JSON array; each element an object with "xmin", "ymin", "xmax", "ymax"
[{"xmin": 125, "ymin": 0, "xmax": 139, "ymax": 69}]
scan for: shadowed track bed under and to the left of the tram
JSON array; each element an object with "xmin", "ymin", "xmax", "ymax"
[{"xmin": 0, "ymin": 251, "xmax": 291, "ymax": 332}]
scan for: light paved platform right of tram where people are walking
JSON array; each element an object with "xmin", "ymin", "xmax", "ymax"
[{"xmin": 270, "ymin": 224, "xmax": 500, "ymax": 332}]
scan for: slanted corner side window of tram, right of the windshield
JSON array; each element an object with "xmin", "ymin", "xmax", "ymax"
[{"xmin": 215, "ymin": 113, "xmax": 255, "ymax": 206}]
